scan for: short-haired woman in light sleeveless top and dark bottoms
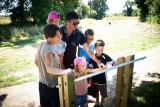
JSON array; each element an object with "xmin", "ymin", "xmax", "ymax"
[{"xmin": 35, "ymin": 24, "xmax": 72, "ymax": 107}]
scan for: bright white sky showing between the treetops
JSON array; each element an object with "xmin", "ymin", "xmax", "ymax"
[{"xmin": 82, "ymin": 0, "xmax": 133, "ymax": 14}]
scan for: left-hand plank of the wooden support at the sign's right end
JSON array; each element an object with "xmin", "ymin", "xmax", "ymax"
[{"xmin": 115, "ymin": 58, "xmax": 125, "ymax": 107}]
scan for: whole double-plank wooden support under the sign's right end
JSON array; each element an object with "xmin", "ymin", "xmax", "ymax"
[{"xmin": 115, "ymin": 55, "xmax": 134, "ymax": 107}]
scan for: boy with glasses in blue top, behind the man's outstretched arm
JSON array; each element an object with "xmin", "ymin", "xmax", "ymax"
[{"xmin": 78, "ymin": 29, "xmax": 94, "ymax": 62}]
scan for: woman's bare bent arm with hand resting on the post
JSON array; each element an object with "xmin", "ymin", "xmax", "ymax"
[{"xmin": 45, "ymin": 52, "xmax": 71, "ymax": 75}]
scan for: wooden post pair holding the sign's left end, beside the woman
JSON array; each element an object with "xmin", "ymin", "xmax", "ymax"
[{"xmin": 58, "ymin": 76, "xmax": 76, "ymax": 107}]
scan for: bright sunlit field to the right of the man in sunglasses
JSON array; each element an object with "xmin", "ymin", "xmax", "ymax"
[{"xmin": 79, "ymin": 17, "xmax": 160, "ymax": 56}]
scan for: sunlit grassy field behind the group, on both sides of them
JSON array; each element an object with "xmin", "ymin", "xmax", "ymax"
[{"xmin": 0, "ymin": 17, "xmax": 160, "ymax": 88}]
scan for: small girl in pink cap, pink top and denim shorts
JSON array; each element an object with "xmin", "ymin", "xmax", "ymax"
[{"xmin": 74, "ymin": 57, "xmax": 100, "ymax": 107}]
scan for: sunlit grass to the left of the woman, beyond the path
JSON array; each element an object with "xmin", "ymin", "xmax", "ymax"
[{"xmin": 0, "ymin": 36, "xmax": 43, "ymax": 88}]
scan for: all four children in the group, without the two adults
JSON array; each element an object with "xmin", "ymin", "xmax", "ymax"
[{"xmin": 43, "ymin": 11, "xmax": 122, "ymax": 107}]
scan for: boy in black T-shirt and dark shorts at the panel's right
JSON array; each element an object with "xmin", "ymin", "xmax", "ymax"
[{"xmin": 90, "ymin": 40, "xmax": 123, "ymax": 105}]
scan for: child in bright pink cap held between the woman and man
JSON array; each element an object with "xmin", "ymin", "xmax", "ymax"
[{"xmin": 46, "ymin": 11, "xmax": 67, "ymax": 69}]
